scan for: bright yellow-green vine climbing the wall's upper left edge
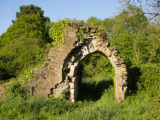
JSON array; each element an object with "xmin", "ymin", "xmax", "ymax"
[{"xmin": 49, "ymin": 20, "xmax": 68, "ymax": 46}]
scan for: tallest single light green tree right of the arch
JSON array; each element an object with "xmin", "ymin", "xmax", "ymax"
[{"xmin": 110, "ymin": 5, "xmax": 155, "ymax": 66}]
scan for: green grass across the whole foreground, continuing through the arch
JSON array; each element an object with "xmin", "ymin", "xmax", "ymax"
[{"xmin": 0, "ymin": 65, "xmax": 160, "ymax": 120}]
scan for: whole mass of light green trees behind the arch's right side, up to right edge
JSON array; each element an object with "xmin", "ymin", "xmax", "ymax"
[{"xmin": 87, "ymin": 5, "xmax": 160, "ymax": 66}]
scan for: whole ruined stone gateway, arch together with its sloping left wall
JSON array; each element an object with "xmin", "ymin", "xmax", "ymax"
[{"xmin": 27, "ymin": 21, "xmax": 128, "ymax": 102}]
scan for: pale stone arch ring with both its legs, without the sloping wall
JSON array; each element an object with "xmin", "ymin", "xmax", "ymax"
[{"xmin": 63, "ymin": 35, "xmax": 127, "ymax": 102}]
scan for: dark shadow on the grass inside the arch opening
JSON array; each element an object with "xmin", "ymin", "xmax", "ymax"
[{"xmin": 78, "ymin": 79, "xmax": 113, "ymax": 101}]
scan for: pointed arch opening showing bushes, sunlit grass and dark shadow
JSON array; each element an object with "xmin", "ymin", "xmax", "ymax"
[{"xmin": 75, "ymin": 51, "xmax": 115, "ymax": 101}]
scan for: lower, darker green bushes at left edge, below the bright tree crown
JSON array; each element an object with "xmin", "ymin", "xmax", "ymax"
[{"xmin": 0, "ymin": 38, "xmax": 46, "ymax": 79}]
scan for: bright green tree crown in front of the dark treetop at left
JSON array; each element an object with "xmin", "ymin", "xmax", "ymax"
[{"xmin": 0, "ymin": 14, "xmax": 47, "ymax": 46}]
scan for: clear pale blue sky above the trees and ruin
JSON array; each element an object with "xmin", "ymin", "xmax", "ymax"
[{"xmin": 0, "ymin": 0, "xmax": 120, "ymax": 35}]
